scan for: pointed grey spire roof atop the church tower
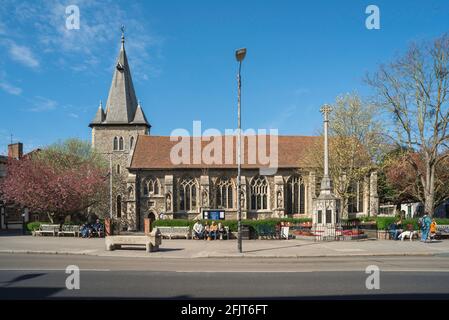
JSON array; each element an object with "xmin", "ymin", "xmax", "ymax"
[{"xmin": 91, "ymin": 26, "xmax": 150, "ymax": 127}]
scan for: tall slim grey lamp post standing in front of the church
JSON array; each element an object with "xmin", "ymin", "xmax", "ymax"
[{"xmin": 235, "ymin": 48, "xmax": 246, "ymax": 253}]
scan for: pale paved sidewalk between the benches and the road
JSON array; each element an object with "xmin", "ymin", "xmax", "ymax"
[{"xmin": 0, "ymin": 233, "xmax": 449, "ymax": 258}]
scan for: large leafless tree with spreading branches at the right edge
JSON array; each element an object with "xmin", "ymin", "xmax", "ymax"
[{"xmin": 367, "ymin": 34, "xmax": 449, "ymax": 214}]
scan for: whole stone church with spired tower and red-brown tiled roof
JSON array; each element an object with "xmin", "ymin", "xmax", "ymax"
[{"xmin": 89, "ymin": 34, "xmax": 378, "ymax": 230}]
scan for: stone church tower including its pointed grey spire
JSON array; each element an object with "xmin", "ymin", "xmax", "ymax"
[{"xmin": 89, "ymin": 27, "xmax": 151, "ymax": 225}]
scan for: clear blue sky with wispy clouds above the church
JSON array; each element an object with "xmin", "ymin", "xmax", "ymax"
[{"xmin": 0, "ymin": 0, "xmax": 449, "ymax": 153}]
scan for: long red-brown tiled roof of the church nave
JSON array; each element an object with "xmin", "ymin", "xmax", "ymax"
[{"xmin": 130, "ymin": 135, "xmax": 321, "ymax": 169}]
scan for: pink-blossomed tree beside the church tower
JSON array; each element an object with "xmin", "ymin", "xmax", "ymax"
[{"xmin": 1, "ymin": 139, "xmax": 108, "ymax": 222}]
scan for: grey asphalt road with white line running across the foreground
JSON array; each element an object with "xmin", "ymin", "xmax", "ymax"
[{"xmin": 0, "ymin": 254, "xmax": 449, "ymax": 299}]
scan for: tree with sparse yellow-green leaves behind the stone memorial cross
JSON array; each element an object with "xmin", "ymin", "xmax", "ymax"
[{"xmin": 313, "ymin": 93, "xmax": 384, "ymax": 218}]
